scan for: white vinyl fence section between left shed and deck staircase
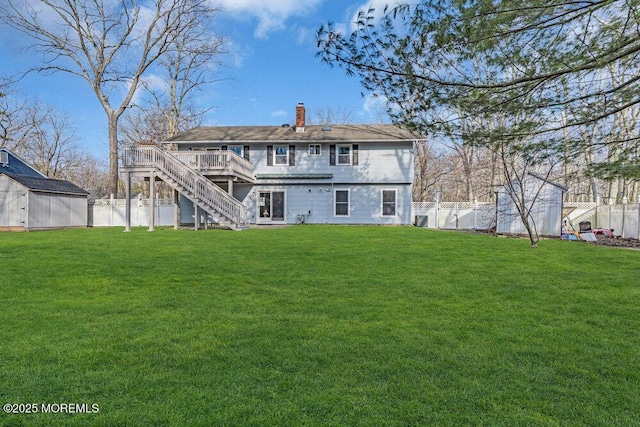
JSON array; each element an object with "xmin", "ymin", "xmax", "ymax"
[{"xmin": 88, "ymin": 197, "xmax": 173, "ymax": 227}]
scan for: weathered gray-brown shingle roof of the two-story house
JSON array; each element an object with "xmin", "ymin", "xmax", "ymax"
[{"xmin": 165, "ymin": 125, "xmax": 424, "ymax": 144}]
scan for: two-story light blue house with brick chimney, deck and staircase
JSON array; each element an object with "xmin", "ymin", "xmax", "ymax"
[{"xmin": 122, "ymin": 104, "xmax": 420, "ymax": 229}]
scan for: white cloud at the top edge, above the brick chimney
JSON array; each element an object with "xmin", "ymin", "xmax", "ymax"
[{"xmin": 220, "ymin": 0, "xmax": 324, "ymax": 38}]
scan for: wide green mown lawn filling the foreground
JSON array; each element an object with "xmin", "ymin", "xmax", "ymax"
[{"xmin": 0, "ymin": 226, "xmax": 640, "ymax": 426}]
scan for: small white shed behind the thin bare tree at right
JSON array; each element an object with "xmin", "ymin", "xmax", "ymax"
[{"xmin": 496, "ymin": 173, "xmax": 567, "ymax": 236}]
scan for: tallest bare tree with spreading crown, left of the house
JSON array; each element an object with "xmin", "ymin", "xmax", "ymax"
[{"xmin": 0, "ymin": 0, "xmax": 225, "ymax": 194}]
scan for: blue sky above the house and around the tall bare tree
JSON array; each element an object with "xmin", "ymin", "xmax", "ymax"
[{"xmin": 0, "ymin": 0, "xmax": 386, "ymax": 156}]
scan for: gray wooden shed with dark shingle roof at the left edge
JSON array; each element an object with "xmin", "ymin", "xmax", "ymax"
[{"xmin": 0, "ymin": 148, "xmax": 89, "ymax": 230}]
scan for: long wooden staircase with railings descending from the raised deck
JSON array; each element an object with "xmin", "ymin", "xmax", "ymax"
[{"xmin": 122, "ymin": 145, "xmax": 248, "ymax": 230}]
